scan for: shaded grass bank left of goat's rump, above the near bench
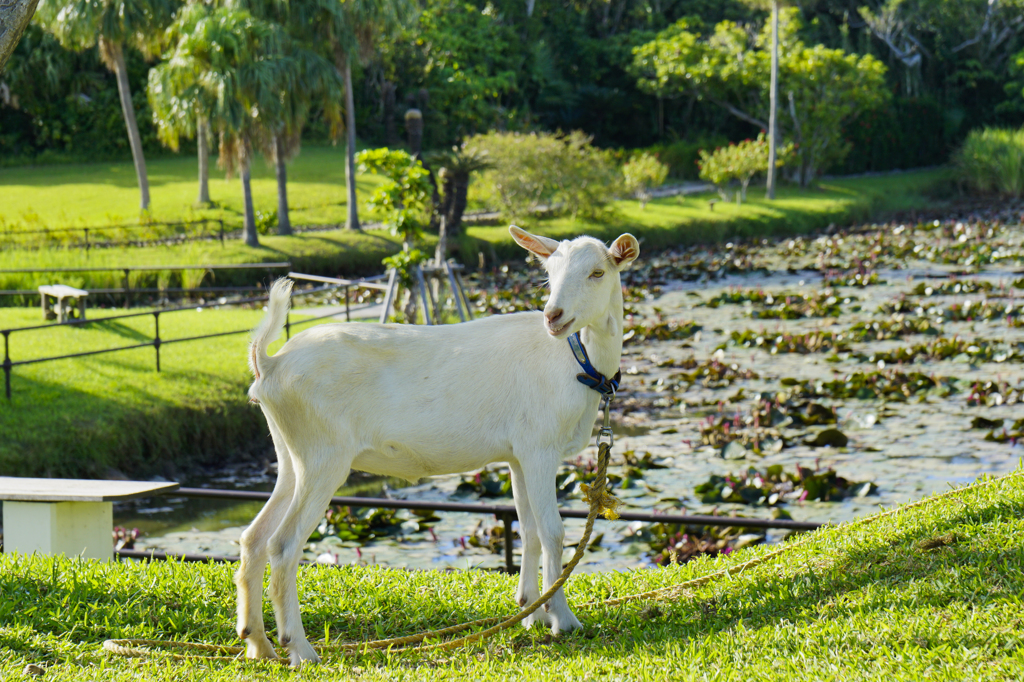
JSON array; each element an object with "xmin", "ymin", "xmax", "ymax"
[{"xmin": 0, "ymin": 366, "xmax": 270, "ymax": 478}]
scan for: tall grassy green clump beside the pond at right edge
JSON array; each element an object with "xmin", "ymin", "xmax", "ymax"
[{"xmin": 953, "ymin": 128, "xmax": 1024, "ymax": 198}]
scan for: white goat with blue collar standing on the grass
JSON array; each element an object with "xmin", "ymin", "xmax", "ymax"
[{"xmin": 234, "ymin": 226, "xmax": 639, "ymax": 666}]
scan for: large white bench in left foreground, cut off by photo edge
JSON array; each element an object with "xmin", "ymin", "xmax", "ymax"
[{"xmin": 0, "ymin": 476, "xmax": 178, "ymax": 561}]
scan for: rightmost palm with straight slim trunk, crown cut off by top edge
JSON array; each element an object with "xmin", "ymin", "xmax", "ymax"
[{"xmin": 290, "ymin": 0, "xmax": 413, "ymax": 229}]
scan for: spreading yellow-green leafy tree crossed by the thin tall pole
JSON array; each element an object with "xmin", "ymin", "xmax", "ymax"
[{"xmin": 634, "ymin": 9, "xmax": 888, "ymax": 186}]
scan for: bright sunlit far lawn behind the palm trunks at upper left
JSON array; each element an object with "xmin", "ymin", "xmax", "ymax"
[{"xmin": 0, "ymin": 144, "xmax": 381, "ymax": 229}]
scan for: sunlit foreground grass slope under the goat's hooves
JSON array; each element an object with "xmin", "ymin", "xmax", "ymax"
[{"xmin": 0, "ymin": 472, "xmax": 1024, "ymax": 682}]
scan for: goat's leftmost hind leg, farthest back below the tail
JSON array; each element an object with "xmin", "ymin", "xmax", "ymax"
[{"xmin": 234, "ymin": 419, "xmax": 295, "ymax": 658}]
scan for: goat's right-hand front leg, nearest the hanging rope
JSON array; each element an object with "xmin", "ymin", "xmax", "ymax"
[{"xmin": 523, "ymin": 453, "xmax": 582, "ymax": 635}]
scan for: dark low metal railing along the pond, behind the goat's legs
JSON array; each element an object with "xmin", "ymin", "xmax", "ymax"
[{"xmin": 115, "ymin": 487, "xmax": 825, "ymax": 573}]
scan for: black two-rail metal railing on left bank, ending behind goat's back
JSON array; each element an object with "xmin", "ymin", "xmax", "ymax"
[{"xmin": 0, "ymin": 270, "xmax": 379, "ymax": 400}]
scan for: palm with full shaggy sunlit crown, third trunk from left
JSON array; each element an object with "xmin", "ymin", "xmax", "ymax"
[{"xmin": 155, "ymin": 4, "xmax": 301, "ymax": 246}]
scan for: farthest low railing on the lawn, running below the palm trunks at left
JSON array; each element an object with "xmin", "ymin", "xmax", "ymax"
[{"xmin": 0, "ymin": 218, "xmax": 225, "ymax": 251}]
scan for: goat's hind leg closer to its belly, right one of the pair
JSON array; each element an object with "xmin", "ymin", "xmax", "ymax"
[{"xmin": 270, "ymin": 456, "xmax": 348, "ymax": 667}]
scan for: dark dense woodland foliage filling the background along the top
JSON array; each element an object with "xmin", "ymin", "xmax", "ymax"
[{"xmin": 8, "ymin": 0, "xmax": 1024, "ymax": 173}]
